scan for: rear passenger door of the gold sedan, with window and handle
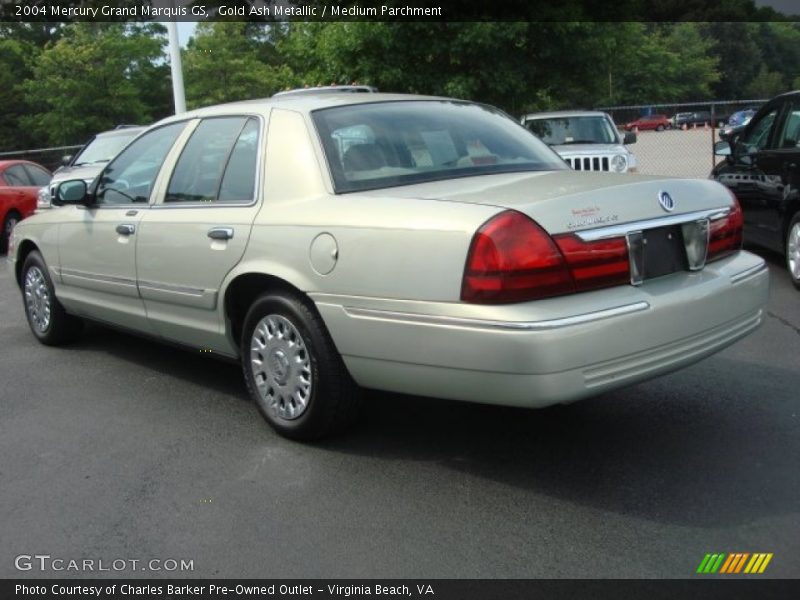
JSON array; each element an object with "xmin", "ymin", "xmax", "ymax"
[{"xmin": 136, "ymin": 115, "xmax": 264, "ymax": 349}]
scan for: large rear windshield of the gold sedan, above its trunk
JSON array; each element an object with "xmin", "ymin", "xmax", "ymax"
[{"xmin": 312, "ymin": 100, "xmax": 568, "ymax": 193}]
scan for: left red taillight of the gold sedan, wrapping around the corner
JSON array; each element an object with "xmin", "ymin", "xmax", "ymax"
[{"xmin": 461, "ymin": 210, "xmax": 630, "ymax": 304}]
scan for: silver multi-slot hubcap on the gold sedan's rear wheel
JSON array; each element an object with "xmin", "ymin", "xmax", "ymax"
[{"xmin": 250, "ymin": 315, "xmax": 312, "ymax": 421}]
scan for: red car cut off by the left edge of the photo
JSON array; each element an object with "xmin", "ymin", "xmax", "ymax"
[{"xmin": 0, "ymin": 160, "xmax": 52, "ymax": 253}]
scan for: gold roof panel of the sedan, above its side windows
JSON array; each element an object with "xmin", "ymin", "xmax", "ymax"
[{"xmin": 156, "ymin": 92, "xmax": 473, "ymax": 123}]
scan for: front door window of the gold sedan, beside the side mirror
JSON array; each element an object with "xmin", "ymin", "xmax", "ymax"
[{"xmin": 97, "ymin": 122, "xmax": 186, "ymax": 204}]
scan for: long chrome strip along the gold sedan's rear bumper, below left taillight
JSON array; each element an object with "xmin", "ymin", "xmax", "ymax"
[{"xmin": 342, "ymin": 301, "xmax": 650, "ymax": 331}]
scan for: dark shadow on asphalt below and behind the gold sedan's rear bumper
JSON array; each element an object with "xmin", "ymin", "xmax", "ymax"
[{"xmin": 324, "ymin": 357, "xmax": 800, "ymax": 527}]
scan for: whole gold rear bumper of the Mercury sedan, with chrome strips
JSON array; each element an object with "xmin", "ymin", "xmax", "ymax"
[{"xmin": 313, "ymin": 252, "xmax": 769, "ymax": 407}]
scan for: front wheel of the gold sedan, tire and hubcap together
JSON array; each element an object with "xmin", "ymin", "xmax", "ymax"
[{"xmin": 22, "ymin": 250, "xmax": 83, "ymax": 346}]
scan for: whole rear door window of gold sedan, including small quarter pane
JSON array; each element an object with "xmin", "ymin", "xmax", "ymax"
[{"xmin": 165, "ymin": 117, "xmax": 258, "ymax": 203}]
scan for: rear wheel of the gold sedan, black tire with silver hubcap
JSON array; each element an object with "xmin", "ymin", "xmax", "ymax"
[{"xmin": 241, "ymin": 292, "xmax": 361, "ymax": 440}]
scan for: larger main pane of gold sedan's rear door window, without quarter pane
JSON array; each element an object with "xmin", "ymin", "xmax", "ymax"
[{"xmin": 165, "ymin": 117, "xmax": 252, "ymax": 202}]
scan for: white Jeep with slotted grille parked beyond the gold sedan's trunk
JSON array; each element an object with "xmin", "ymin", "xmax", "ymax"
[{"xmin": 522, "ymin": 110, "xmax": 638, "ymax": 173}]
